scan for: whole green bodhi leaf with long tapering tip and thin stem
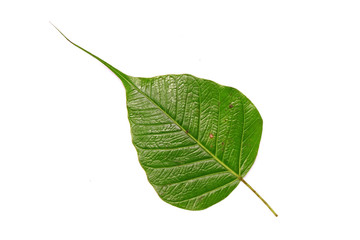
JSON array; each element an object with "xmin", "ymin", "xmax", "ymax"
[{"xmin": 52, "ymin": 25, "xmax": 277, "ymax": 216}]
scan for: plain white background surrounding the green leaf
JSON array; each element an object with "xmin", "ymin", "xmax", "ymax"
[{"xmin": 0, "ymin": 0, "xmax": 360, "ymax": 240}]
